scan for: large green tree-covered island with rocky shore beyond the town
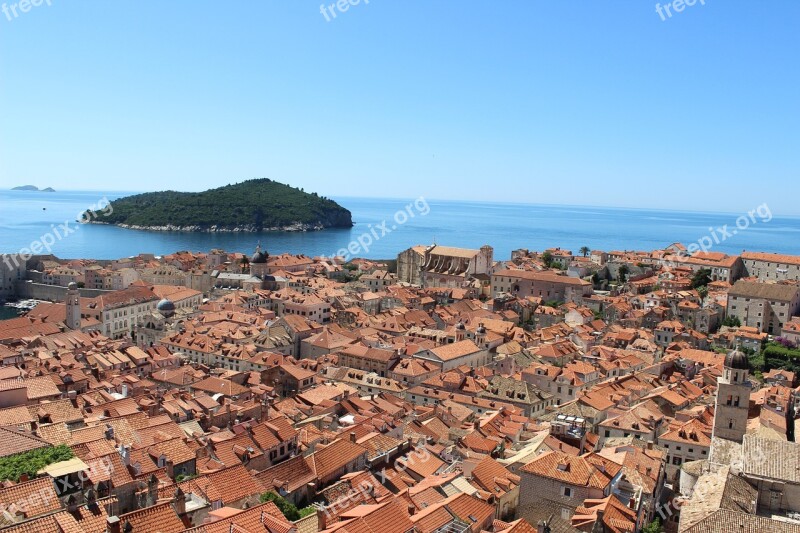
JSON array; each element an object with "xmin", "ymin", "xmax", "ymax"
[{"xmin": 83, "ymin": 179, "xmax": 353, "ymax": 232}]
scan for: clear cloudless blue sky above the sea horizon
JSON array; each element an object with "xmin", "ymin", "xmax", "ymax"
[{"xmin": 0, "ymin": 0, "xmax": 800, "ymax": 214}]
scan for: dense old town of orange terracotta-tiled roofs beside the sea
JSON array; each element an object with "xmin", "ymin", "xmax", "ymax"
[{"xmin": 0, "ymin": 243, "xmax": 800, "ymax": 533}]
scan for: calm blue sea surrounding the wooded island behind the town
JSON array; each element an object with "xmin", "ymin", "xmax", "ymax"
[{"xmin": 0, "ymin": 191, "xmax": 800, "ymax": 259}]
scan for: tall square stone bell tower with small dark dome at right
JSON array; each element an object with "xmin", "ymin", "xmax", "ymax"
[{"xmin": 713, "ymin": 348, "xmax": 750, "ymax": 443}]
